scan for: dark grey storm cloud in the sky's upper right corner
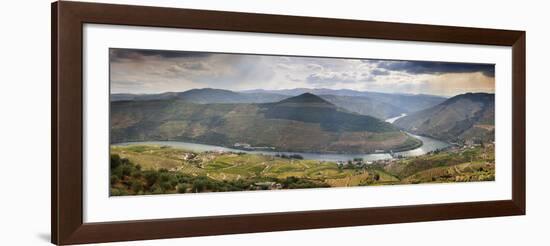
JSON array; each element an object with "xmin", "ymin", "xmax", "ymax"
[{"xmin": 377, "ymin": 61, "xmax": 495, "ymax": 77}]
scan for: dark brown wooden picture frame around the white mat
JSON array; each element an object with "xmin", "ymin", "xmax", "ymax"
[{"xmin": 51, "ymin": 1, "xmax": 526, "ymax": 244}]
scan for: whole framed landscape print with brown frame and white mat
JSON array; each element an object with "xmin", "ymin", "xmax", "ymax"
[{"xmin": 52, "ymin": 1, "xmax": 525, "ymax": 244}]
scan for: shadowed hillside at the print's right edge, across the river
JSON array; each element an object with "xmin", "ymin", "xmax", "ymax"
[{"xmin": 394, "ymin": 93, "xmax": 495, "ymax": 142}]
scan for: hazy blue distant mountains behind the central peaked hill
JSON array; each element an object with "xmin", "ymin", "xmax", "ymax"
[{"xmin": 111, "ymin": 88, "xmax": 446, "ymax": 119}]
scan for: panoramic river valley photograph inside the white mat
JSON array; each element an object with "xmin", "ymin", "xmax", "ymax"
[{"xmin": 109, "ymin": 48, "xmax": 495, "ymax": 196}]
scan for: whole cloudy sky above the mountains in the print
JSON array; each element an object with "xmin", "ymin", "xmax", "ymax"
[{"xmin": 109, "ymin": 49, "xmax": 495, "ymax": 96}]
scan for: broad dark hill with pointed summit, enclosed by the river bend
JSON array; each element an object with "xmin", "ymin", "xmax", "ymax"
[{"xmin": 111, "ymin": 92, "xmax": 421, "ymax": 153}]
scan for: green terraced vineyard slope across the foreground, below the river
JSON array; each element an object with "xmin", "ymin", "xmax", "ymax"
[{"xmin": 111, "ymin": 145, "xmax": 495, "ymax": 195}]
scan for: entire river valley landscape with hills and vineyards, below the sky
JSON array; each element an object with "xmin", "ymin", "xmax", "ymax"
[{"xmin": 110, "ymin": 89, "xmax": 495, "ymax": 196}]
